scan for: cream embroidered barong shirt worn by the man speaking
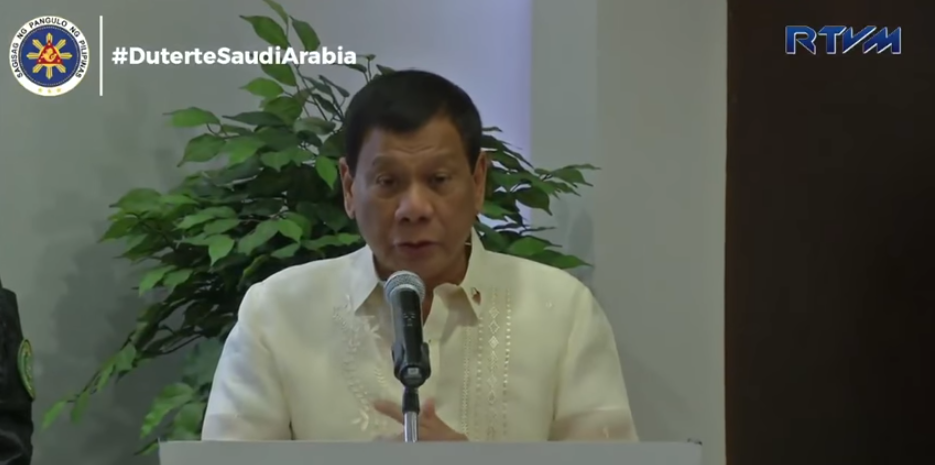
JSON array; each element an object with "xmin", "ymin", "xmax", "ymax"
[{"xmin": 202, "ymin": 233, "xmax": 636, "ymax": 442}]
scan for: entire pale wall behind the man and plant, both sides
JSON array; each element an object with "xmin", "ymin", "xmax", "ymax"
[{"xmin": 0, "ymin": 0, "xmax": 726, "ymax": 465}]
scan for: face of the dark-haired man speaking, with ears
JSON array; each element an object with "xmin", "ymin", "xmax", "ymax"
[{"xmin": 341, "ymin": 118, "xmax": 487, "ymax": 284}]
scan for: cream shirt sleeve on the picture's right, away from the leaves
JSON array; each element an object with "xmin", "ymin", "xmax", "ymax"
[{"xmin": 550, "ymin": 285, "xmax": 637, "ymax": 442}]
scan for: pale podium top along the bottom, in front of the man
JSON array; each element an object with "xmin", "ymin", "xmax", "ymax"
[{"xmin": 159, "ymin": 441, "xmax": 702, "ymax": 465}]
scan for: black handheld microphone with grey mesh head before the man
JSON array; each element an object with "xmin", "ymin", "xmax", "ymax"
[{"xmin": 383, "ymin": 271, "xmax": 431, "ymax": 389}]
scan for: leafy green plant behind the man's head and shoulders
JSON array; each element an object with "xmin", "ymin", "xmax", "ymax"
[{"xmin": 43, "ymin": 0, "xmax": 595, "ymax": 453}]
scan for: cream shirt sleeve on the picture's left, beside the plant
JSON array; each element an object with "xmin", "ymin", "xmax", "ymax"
[{"xmin": 201, "ymin": 283, "xmax": 292, "ymax": 441}]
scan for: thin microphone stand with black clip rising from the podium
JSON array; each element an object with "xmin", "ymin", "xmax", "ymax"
[{"xmin": 393, "ymin": 342, "xmax": 432, "ymax": 442}]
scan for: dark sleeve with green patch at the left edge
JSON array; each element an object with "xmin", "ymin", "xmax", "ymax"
[{"xmin": 0, "ymin": 284, "xmax": 33, "ymax": 465}]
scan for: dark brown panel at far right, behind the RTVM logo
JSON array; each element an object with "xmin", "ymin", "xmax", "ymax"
[{"xmin": 725, "ymin": 0, "xmax": 935, "ymax": 465}]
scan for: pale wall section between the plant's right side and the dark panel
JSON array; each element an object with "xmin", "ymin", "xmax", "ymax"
[{"xmin": 532, "ymin": 0, "xmax": 727, "ymax": 465}]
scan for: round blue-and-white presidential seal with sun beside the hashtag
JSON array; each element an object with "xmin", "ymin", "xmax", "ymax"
[{"xmin": 10, "ymin": 16, "xmax": 90, "ymax": 97}]
